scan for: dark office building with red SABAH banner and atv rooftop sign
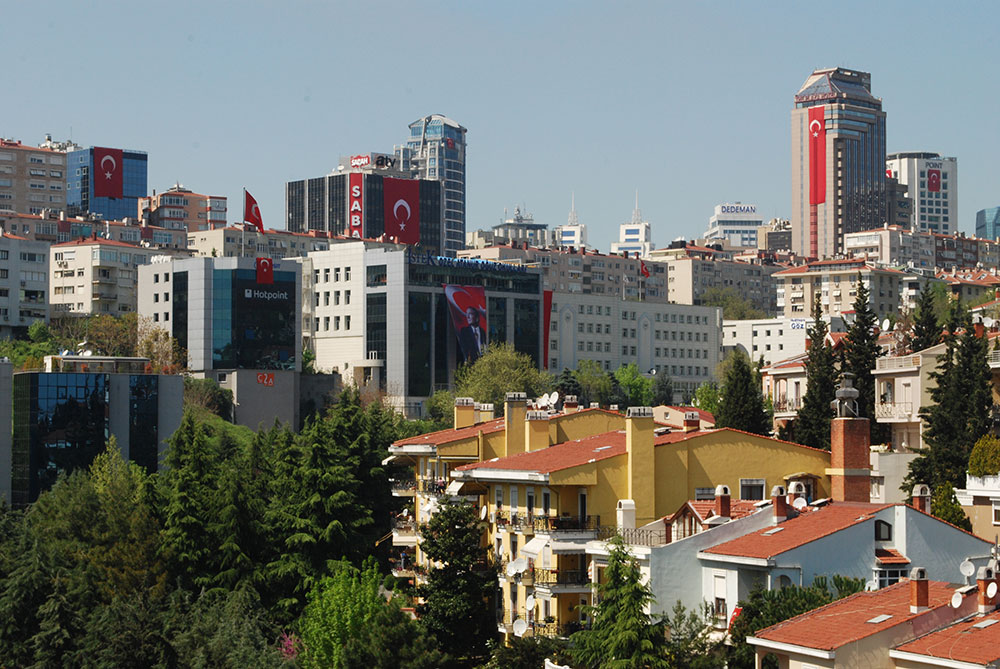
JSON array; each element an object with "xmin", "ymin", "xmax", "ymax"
[{"xmin": 285, "ymin": 153, "xmax": 438, "ymax": 254}]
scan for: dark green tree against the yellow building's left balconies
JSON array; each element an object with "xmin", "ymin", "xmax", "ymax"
[{"xmin": 417, "ymin": 500, "xmax": 496, "ymax": 660}]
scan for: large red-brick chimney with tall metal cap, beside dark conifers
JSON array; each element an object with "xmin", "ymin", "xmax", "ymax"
[{"xmin": 826, "ymin": 373, "xmax": 871, "ymax": 502}]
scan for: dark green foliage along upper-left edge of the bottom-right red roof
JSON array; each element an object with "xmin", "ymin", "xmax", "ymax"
[{"xmin": 727, "ymin": 575, "xmax": 864, "ymax": 669}]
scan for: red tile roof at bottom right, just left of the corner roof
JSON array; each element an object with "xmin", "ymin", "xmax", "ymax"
[{"xmin": 754, "ymin": 576, "xmax": 958, "ymax": 650}]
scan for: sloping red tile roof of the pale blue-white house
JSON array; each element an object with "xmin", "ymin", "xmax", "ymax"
[{"xmin": 704, "ymin": 502, "xmax": 893, "ymax": 559}]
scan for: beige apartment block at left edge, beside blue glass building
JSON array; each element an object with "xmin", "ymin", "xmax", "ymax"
[{"xmin": 0, "ymin": 137, "xmax": 75, "ymax": 214}]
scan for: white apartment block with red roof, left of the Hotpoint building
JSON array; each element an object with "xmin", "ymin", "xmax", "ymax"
[{"xmin": 48, "ymin": 235, "xmax": 156, "ymax": 316}]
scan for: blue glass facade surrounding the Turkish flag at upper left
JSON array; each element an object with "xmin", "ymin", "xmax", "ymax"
[{"xmin": 66, "ymin": 148, "xmax": 148, "ymax": 220}]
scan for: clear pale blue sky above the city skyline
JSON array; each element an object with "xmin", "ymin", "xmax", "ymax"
[{"xmin": 7, "ymin": 0, "xmax": 1000, "ymax": 250}]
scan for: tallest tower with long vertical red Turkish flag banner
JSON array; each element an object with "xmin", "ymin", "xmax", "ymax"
[{"xmin": 791, "ymin": 67, "xmax": 887, "ymax": 258}]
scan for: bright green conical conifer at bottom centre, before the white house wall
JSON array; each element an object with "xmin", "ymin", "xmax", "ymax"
[{"xmin": 570, "ymin": 536, "xmax": 669, "ymax": 669}]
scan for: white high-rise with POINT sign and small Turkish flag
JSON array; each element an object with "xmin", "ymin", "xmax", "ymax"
[{"xmin": 885, "ymin": 151, "xmax": 958, "ymax": 235}]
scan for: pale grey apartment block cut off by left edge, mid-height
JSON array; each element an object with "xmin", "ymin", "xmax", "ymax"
[{"xmin": 0, "ymin": 232, "xmax": 49, "ymax": 337}]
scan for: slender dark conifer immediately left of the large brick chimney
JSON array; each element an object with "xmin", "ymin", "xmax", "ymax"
[{"xmin": 795, "ymin": 293, "xmax": 837, "ymax": 450}]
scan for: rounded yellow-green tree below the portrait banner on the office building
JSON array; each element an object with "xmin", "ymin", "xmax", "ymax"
[{"xmin": 455, "ymin": 343, "xmax": 552, "ymax": 411}]
